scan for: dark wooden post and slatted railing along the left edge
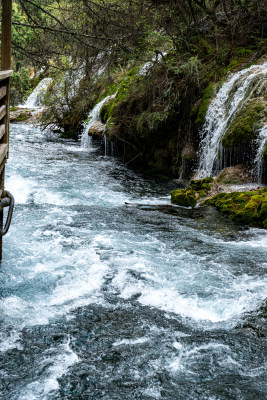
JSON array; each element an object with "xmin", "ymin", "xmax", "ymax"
[{"xmin": 0, "ymin": 0, "xmax": 12, "ymax": 259}]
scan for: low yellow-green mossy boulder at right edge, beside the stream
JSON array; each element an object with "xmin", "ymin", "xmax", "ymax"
[{"xmin": 204, "ymin": 187, "xmax": 267, "ymax": 229}]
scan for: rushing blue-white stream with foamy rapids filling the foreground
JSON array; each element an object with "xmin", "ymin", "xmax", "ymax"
[{"xmin": 0, "ymin": 125, "xmax": 267, "ymax": 400}]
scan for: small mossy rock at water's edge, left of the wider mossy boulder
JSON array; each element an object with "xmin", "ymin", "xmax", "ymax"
[{"xmin": 171, "ymin": 178, "xmax": 214, "ymax": 208}]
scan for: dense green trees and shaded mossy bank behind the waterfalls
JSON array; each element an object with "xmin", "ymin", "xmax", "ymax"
[{"xmin": 5, "ymin": 0, "xmax": 267, "ymax": 177}]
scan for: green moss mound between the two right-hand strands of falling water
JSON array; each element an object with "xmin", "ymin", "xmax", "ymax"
[{"xmin": 222, "ymin": 100, "xmax": 267, "ymax": 148}]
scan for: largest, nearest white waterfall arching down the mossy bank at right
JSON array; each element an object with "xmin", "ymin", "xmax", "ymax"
[{"xmin": 198, "ymin": 63, "xmax": 267, "ymax": 178}]
